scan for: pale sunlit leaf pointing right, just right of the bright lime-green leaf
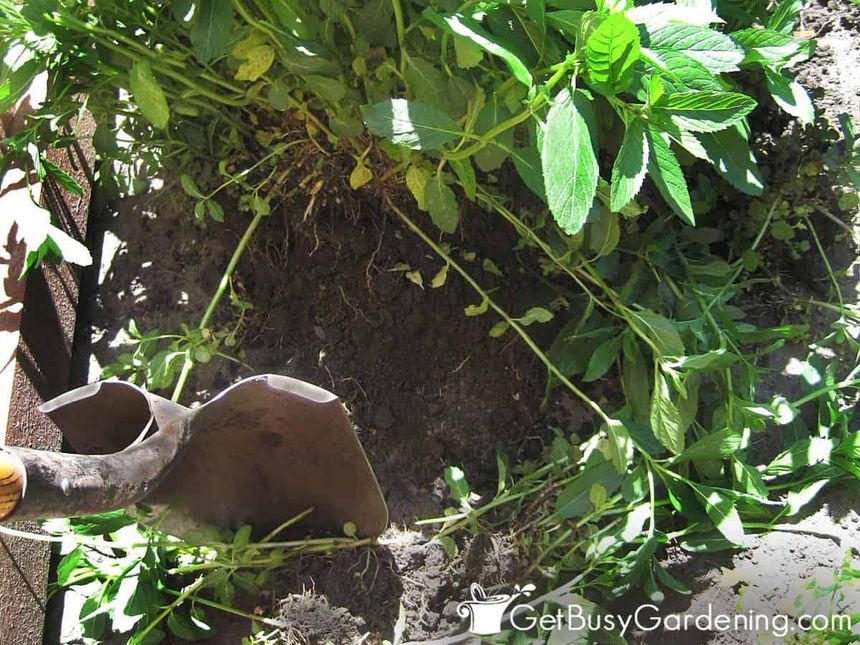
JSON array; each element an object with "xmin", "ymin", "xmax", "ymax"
[{"xmin": 647, "ymin": 24, "xmax": 744, "ymax": 74}]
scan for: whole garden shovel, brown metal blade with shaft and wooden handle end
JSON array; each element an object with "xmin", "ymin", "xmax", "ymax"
[{"xmin": 0, "ymin": 374, "xmax": 388, "ymax": 537}]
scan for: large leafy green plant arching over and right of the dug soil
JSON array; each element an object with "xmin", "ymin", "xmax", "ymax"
[{"xmin": 0, "ymin": 0, "xmax": 860, "ymax": 640}]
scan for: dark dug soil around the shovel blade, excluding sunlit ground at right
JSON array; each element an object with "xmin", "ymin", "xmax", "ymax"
[{"xmin": 70, "ymin": 180, "xmax": 585, "ymax": 643}]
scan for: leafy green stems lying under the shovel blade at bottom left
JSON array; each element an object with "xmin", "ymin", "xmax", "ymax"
[{"xmin": 32, "ymin": 511, "xmax": 368, "ymax": 645}]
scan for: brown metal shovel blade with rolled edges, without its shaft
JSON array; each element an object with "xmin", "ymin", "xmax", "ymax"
[{"xmin": 40, "ymin": 374, "xmax": 388, "ymax": 537}]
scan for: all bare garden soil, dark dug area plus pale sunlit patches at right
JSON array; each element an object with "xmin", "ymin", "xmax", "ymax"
[{"xmin": 60, "ymin": 1, "xmax": 860, "ymax": 643}]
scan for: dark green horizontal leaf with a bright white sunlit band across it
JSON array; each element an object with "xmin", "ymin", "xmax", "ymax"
[{"xmin": 361, "ymin": 99, "xmax": 463, "ymax": 150}]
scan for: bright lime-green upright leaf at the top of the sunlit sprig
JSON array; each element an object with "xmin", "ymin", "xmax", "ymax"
[{"xmin": 585, "ymin": 13, "xmax": 639, "ymax": 95}]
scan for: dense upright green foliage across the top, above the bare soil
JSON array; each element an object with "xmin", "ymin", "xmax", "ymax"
[{"xmin": 0, "ymin": 0, "xmax": 813, "ymax": 260}]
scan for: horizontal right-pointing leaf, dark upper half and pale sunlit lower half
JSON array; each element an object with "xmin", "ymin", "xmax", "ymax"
[{"xmin": 652, "ymin": 92, "xmax": 756, "ymax": 132}]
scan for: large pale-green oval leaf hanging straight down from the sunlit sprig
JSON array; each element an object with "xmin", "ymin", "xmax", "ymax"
[{"xmin": 541, "ymin": 88, "xmax": 598, "ymax": 235}]
